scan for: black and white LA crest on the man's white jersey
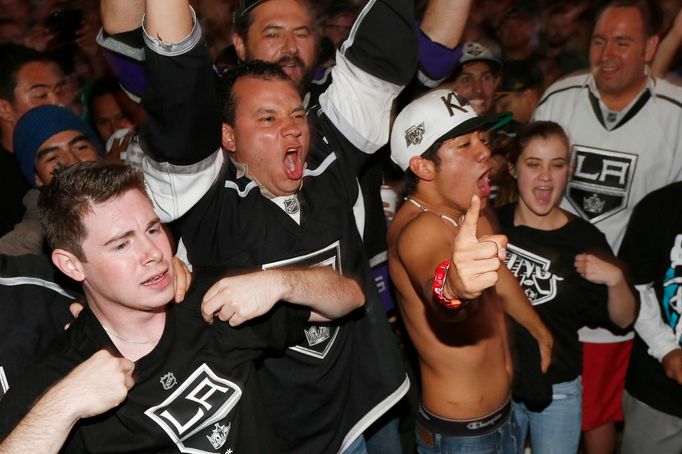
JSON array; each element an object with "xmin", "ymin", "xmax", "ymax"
[{"xmin": 566, "ymin": 145, "xmax": 637, "ymax": 224}]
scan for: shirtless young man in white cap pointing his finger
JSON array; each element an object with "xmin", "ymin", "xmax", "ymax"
[{"xmin": 388, "ymin": 90, "xmax": 532, "ymax": 453}]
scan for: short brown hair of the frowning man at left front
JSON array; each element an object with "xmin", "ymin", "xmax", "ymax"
[{"xmin": 38, "ymin": 161, "xmax": 147, "ymax": 262}]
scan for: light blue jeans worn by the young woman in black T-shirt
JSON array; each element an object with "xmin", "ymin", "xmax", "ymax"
[{"xmin": 512, "ymin": 377, "xmax": 583, "ymax": 454}]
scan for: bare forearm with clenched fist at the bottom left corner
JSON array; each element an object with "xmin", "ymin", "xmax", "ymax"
[{"xmin": 0, "ymin": 350, "xmax": 135, "ymax": 454}]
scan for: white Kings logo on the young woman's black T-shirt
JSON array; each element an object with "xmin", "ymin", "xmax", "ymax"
[{"xmin": 504, "ymin": 244, "xmax": 564, "ymax": 306}]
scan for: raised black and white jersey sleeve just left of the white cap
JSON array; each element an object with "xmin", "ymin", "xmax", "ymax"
[{"xmin": 320, "ymin": 0, "xmax": 417, "ymax": 153}]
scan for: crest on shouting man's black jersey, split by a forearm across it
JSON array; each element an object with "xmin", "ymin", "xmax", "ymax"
[{"xmin": 263, "ymin": 241, "xmax": 342, "ymax": 359}]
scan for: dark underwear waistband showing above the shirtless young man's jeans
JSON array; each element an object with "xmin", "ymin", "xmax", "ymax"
[{"xmin": 417, "ymin": 398, "xmax": 511, "ymax": 437}]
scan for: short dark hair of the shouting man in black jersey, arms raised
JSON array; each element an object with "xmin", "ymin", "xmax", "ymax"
[{"xmin": 217, "ymin": 60, "xmax": 290, "ymax": 125}]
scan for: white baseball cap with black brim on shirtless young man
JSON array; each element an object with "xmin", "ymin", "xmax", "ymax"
[{"xmin": 391, "ymin": 89, "xmax": 512, "ymax": 170}]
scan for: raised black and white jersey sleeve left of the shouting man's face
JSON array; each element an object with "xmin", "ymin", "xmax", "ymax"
[{"xmin": 142, "ymin": 13, "xmax": 223, "ymax": 222}]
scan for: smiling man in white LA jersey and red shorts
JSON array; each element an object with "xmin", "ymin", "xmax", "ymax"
[{"xmin": 535, "ymin": 0, "xmax": 682, "ymax": 454}]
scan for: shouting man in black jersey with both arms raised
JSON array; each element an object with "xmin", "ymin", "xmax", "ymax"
[{"xmin": 127, "ymin": 0, "xmax": 416, "ymax": 453}]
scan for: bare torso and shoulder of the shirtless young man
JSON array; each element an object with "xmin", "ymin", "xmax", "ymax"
[{"xmin": 388, "ymin": 204, "xmax": 512, "ymax": 419}]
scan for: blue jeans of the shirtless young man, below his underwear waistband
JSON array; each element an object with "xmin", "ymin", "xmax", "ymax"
[{"xmin": 417, "ymin": 412, "xmax": 523, "ymax": 454}]
